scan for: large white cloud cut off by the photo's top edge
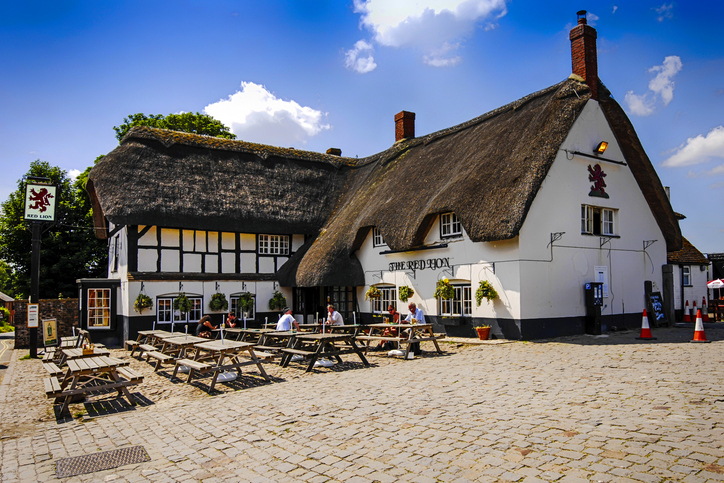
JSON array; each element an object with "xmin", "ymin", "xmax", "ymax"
[{"xmin": 354, "ymin": 0, "xmax": 509, "ymax": 66}]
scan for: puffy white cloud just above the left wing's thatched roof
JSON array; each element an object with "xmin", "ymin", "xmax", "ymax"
[{"xmin": 204, "ymin": 82, "xmax": 331, "ymax": 146}]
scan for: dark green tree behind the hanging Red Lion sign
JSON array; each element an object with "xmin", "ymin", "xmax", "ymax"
[{"xmin": 0, "ymin": 160, "xmax": 108, "ymax": 298}]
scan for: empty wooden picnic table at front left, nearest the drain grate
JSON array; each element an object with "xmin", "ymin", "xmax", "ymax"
[{"xmin": 44, "ymin": 356, "xmax": 143, "ymax": 414}]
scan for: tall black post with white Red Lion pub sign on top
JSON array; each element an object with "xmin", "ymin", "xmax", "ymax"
[{"xmin": 23, "ymin": 177, "xmax": 58, "ymax": 358}]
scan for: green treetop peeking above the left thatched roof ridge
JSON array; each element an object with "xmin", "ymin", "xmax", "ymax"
[{"xmin": 113, "ymin": 112, "xmax": 236, "ymax": 142}]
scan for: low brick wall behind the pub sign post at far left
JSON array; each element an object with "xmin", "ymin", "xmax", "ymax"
[{"xmin": 14, "ymin": 299, "xmax": 79, "ymax": 349}]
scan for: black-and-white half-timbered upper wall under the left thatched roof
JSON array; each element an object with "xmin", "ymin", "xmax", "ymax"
[{"xmin": 128, "ymin": 226, "xmax": 304, "ymax": 274}]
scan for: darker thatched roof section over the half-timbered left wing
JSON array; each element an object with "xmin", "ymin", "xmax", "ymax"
[{"xmin": 88, "ymin": 127, "xmax": 355, "ymax": 237}]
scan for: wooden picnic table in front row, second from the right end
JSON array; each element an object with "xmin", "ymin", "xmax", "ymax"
[{"xmin": 280, "ymin": 333, "xmax": 370, "ymax": 372}]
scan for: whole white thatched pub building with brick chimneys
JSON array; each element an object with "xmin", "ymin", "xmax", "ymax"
[{"xmin": 79, "ymin": 12, "xmax": 682, "ymax": 345}]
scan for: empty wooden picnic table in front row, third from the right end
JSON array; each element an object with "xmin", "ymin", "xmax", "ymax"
[{"xmin": 171, "ymin": 339, "xmax": 271, "ymax": 393}]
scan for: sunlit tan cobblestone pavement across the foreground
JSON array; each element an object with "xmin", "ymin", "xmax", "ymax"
[{"xmin": 0, "ymin": 328, "xmax": 724, "ymax": 483}]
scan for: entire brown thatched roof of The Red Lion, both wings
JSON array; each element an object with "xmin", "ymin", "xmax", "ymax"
[{"xmin": 88, "ymin": 78, "xmax": 681, "ymax": 286}]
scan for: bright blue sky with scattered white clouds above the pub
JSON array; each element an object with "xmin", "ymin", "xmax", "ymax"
[{"xmin": 0, "ymin": 0, "xmax": 724, "ymax": 253}]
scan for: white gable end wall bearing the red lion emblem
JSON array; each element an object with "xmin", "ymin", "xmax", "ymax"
[{"xmin": 520, "ymin": 101, "xmax": 666, "ymax": 319}]
